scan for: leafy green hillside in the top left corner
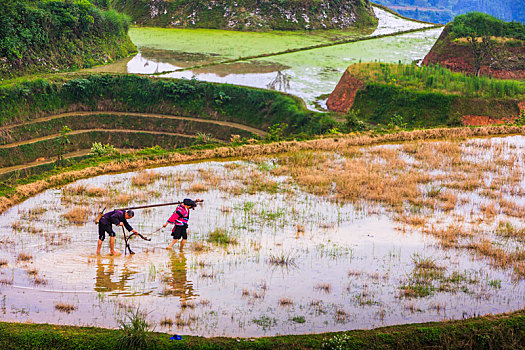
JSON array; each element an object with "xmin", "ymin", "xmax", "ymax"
[{"xmin": 0, "ymin": 0, "xmax": 136, "ymax": 79}]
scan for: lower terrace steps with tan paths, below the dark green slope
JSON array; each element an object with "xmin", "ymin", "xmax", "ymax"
[{"xmin": 0, "ymin": 111, "xmax": 266, "ymax": 168}]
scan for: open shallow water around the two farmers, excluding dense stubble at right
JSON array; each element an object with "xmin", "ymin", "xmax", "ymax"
[{"xmin": 0, "ymin": 139, "xmax": 525, "ymax": 336}]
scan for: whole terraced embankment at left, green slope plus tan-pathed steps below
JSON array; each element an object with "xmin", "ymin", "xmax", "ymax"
[{"xmin": 0, "ymin": 75, "xmax": 333, "ymax": 179}]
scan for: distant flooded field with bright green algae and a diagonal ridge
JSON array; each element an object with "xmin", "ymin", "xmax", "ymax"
[{"xmin": 94, "ymin": 8, "xmax": 442, "ymax": 110}]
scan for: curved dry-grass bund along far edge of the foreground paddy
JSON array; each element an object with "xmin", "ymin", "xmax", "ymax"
[{"xmin": 0, "ymin": 126, "xmax": 525, "ymax": 213}]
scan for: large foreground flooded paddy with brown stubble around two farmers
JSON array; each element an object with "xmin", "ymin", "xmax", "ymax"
[{"xmin": 0, "ymin": 136, "xmax": 525, "ymax": 336}]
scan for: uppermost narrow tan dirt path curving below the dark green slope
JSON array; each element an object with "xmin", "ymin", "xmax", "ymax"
[{"xmin": 0, "ymin": 111, "xmax": 266, "ymax": 136}]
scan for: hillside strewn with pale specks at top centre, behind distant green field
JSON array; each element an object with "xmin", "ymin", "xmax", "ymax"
[{"xmin": 111, "ymin": 0, "xmax": 377, "ymax": 31}]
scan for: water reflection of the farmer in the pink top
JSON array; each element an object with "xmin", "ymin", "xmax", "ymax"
[{"xmin": 165, "ymin": 251, "xmax": 198, "ymax": 301}]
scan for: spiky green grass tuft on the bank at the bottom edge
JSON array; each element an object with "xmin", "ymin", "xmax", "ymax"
[{"xmin": 117, "ymin": 309, "xmax": 155, "ymax": 350}]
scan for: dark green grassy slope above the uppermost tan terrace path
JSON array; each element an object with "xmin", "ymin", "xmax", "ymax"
[{"xmin": 0, "ymin": 74, "xmax": 335, "ymax": 134}]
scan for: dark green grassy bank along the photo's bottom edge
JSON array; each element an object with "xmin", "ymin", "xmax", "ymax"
[{"xmin": 0, "ymin": 310, "xmax": 525, "ymax": 349}]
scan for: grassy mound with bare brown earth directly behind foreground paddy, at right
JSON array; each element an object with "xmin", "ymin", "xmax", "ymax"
[{"xmin": 327, "ymin": 63, "xmax": 525, "ymax": 127}]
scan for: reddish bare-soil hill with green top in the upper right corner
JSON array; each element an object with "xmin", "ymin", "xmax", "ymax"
[{"xmin": 423, "ymin": 13, "xmax": 525, "ymax": 79}]
